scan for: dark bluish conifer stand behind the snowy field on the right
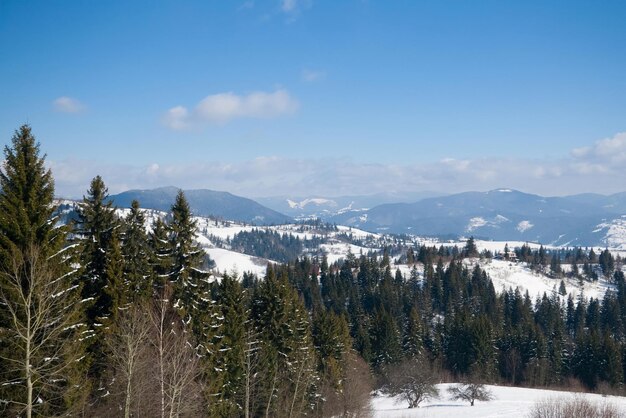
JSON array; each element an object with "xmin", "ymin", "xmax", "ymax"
[{"xmin": 285, "ymin": 247, "xmax": 626, "ymax": 389}]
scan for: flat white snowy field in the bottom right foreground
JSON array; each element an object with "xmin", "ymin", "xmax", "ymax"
[{"xmin": 372, "ymin": 383, "xmax": 626, "ymax": 418}]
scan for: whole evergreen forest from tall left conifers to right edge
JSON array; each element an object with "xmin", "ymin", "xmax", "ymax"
[{"xmin": 0, "ymin": 125, "xmax": 626, "ymax": 417}]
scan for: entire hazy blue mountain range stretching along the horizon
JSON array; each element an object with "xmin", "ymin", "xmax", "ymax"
[{"xmin": 77, "ymin": 187, "xmax": 626, "ymax": 249}]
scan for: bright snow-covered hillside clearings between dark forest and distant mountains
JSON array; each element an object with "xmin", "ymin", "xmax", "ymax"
[{"xmin": 60, "ymin": 201, "xmax": 626, "ymax": 300}]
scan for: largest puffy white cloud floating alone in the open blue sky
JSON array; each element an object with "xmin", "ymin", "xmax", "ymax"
[{"xmin": 163, "ymin": 89, "xmax": 299, "ymax": 130}]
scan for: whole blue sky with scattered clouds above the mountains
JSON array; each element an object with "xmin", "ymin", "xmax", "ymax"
[{"xmin": 0, "ymin": 0, "xmax": 626, "ymax": 197}]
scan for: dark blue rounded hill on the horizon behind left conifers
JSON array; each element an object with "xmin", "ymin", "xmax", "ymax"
[{"xmin": 110, "ymin": 187, "xmax": 292, "ymax": 225}]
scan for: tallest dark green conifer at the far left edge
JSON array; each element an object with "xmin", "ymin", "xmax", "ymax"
[{"xmin": 0, "ymin": 125, "xmax": 89, "ymax": 417}]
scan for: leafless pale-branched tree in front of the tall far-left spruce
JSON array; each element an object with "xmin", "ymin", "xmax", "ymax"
[{"xmin": 0, "ymin": 245, "xmax": 84, "ymax": 417}]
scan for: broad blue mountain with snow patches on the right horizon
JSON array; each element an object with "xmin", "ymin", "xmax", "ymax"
[{"xmin": 330, "ymin": 189, "xmax": 626, "ymax": 248}]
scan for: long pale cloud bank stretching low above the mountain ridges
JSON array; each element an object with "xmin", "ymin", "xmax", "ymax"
[{"xmin": 51, "ymin": 134, "xmax": 626, "ymax": 201}]
